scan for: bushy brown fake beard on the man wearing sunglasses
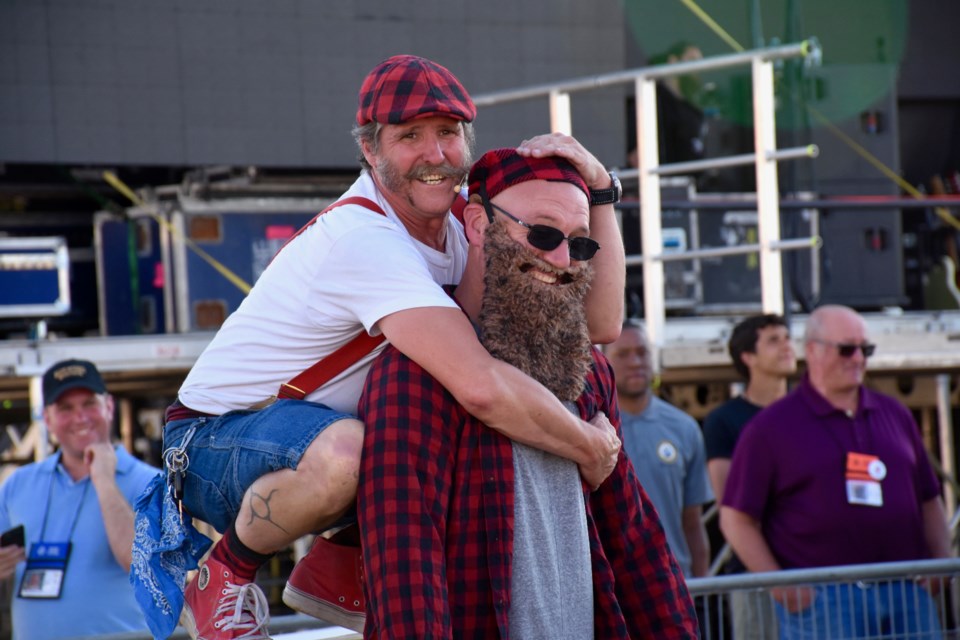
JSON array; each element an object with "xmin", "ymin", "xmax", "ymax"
[{"xmin": 479, "ymin": 223, "xmax": 593, "ymax": 401}]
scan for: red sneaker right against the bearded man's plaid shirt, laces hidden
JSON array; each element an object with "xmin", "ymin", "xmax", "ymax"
[{"xmin": 283, "ymin": 536, "xmax": 367, "ymax": 633}]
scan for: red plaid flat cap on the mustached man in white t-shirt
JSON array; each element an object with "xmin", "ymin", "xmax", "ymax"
[{"xmin": 357, "ymin": 55, "xmax": 477, "ymax": 126}]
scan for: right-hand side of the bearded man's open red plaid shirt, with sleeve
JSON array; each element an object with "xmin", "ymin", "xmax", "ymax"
[{"xmin": 581, "ymin": 350, "xmax": 698, "ymax": 639}]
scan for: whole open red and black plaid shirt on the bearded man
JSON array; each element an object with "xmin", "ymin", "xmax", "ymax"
[{"xmin": 358, "ymin": 347, "xmax": 697, "ymax": 640}]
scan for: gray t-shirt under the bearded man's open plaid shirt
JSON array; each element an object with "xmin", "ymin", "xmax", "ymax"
[{"xmin": 510, "ymin": 405, "xmax": 594, "ymax": 640}]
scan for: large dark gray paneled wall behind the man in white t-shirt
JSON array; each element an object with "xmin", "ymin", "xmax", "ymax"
[{"xmin": 0, "ymin": 0, "xmax": 625, "ymax": 168}]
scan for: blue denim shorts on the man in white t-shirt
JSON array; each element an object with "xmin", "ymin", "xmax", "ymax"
[{"xmin": 163, "ymin": 400, "xmax": 355, "ymax": 533}]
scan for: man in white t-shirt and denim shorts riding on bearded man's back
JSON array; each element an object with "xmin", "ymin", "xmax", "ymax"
[{"xmin": 133, "ymin": 55, "xmax": 624, "ymax": 640}]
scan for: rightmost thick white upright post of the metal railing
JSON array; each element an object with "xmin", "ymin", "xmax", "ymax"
[{"xmin": 752, "ymin": 57, "xmax": 783, "ymax": 314}]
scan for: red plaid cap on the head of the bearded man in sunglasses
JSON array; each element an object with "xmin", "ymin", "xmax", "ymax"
[{"xmin": 469, "ymin": 148, "xmax": 590, "ymax": 199}]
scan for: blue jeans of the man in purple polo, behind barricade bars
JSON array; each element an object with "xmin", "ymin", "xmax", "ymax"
[{"xmin": 777, "ymin": 580, "xmax": 942, "ymax": 640}]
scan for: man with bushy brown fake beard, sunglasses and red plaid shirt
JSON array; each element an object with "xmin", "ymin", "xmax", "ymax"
[{"xmin": 358, "ymin": 149, "xmax": 697, "ymax": 640}]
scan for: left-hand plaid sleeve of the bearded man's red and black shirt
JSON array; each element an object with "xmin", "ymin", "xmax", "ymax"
[{"xmin": 357, "ymin": 347, "xmax": 463, "ymax": 640}]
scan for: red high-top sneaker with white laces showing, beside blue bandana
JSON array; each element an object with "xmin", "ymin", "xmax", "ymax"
[{"xmin": 180, "ymin": 559, "xmax": 270, "ymax": 640}]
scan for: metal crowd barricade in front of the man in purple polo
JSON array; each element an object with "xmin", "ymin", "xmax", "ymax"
[{"xmin": 687, "ymin": 558, "xmax": 960, "ymax": 640}]
